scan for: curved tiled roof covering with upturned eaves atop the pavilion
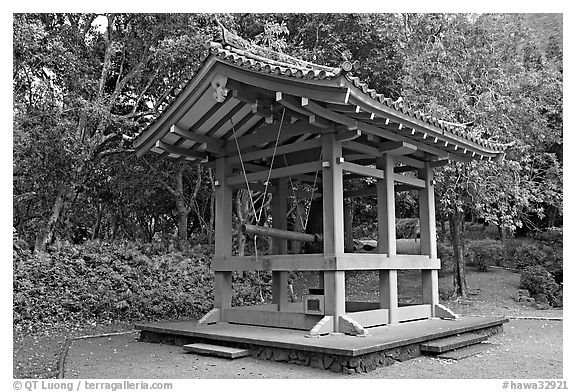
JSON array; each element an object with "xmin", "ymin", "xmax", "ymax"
[{"xmin": 135, "ymin": 22, "xmax": 509, "ymax": 159}]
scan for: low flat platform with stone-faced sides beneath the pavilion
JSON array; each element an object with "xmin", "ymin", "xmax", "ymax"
[{"xmin": 136, "ymin": 317, "xmax": 508, "ymax": 374}]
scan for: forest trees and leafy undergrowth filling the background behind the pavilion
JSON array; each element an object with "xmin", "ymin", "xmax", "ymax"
[{"xmin": 12, "ymin": 14, "xmax": 564, "ymax": 329}]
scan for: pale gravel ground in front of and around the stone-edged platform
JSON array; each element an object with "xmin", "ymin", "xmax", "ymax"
[{"xmin": 65, "ymin": 320, "xmax": 563, "ymax": 379}]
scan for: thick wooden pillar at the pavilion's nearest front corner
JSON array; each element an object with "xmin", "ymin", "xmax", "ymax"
[{"xmin": 322, "ymin": 133, "xmax": 346, "ymax": 332}]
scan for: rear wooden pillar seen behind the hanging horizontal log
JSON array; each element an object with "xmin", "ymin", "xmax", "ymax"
[{"xmin": 272, "ymin": 178, "xmax": 288, "ymax": 312}]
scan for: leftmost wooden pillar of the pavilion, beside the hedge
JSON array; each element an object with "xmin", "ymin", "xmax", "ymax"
[{"xmin": 214, "ymin": 158, "xmax": 232, "ymax": 321}]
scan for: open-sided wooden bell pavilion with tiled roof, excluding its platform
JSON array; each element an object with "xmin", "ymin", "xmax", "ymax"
[{"xmin": 135, "ymin": 27, "xmax": 506, "ymax": 335}]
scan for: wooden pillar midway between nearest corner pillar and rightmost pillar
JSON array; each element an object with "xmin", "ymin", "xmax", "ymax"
[{"xmin": 376, "ymin": 154, "xmax": 398, "ymax": 324}]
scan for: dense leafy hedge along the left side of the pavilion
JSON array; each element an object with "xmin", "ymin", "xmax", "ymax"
[{"xmin": 13, "ymin": 242, "xmax": 267, "ymax": 328}]
